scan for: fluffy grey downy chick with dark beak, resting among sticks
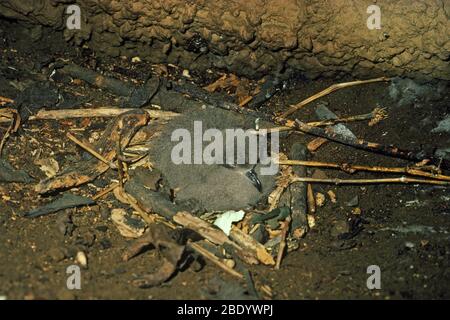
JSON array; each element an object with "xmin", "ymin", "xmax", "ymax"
[{"xmin": 149, "ymin": 107, "xmax": 276, "ymax": 211}]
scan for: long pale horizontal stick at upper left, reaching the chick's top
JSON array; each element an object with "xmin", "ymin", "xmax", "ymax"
[{"xmin": 0, "ymin": 105, "xmax": 179, "ymax": 123}]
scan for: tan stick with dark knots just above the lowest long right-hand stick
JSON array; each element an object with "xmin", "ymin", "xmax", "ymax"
[{"xmin": 278, "ymin": 160, "xmax": 450, "ymax": 181}]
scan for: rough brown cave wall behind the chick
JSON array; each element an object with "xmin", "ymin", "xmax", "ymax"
[{"xmin": 0, "ymin": 0, "xmax": 450, "ymax": 80}]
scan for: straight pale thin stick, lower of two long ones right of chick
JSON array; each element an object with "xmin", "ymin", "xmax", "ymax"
[{"xmin": 291, "ymin": 177, "xmax": 450, "ymax": 186}]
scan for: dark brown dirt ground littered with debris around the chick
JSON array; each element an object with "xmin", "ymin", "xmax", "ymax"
[{"xmin": 0, "ymin": 24, "xmax": 450, "ymax": 299}]
